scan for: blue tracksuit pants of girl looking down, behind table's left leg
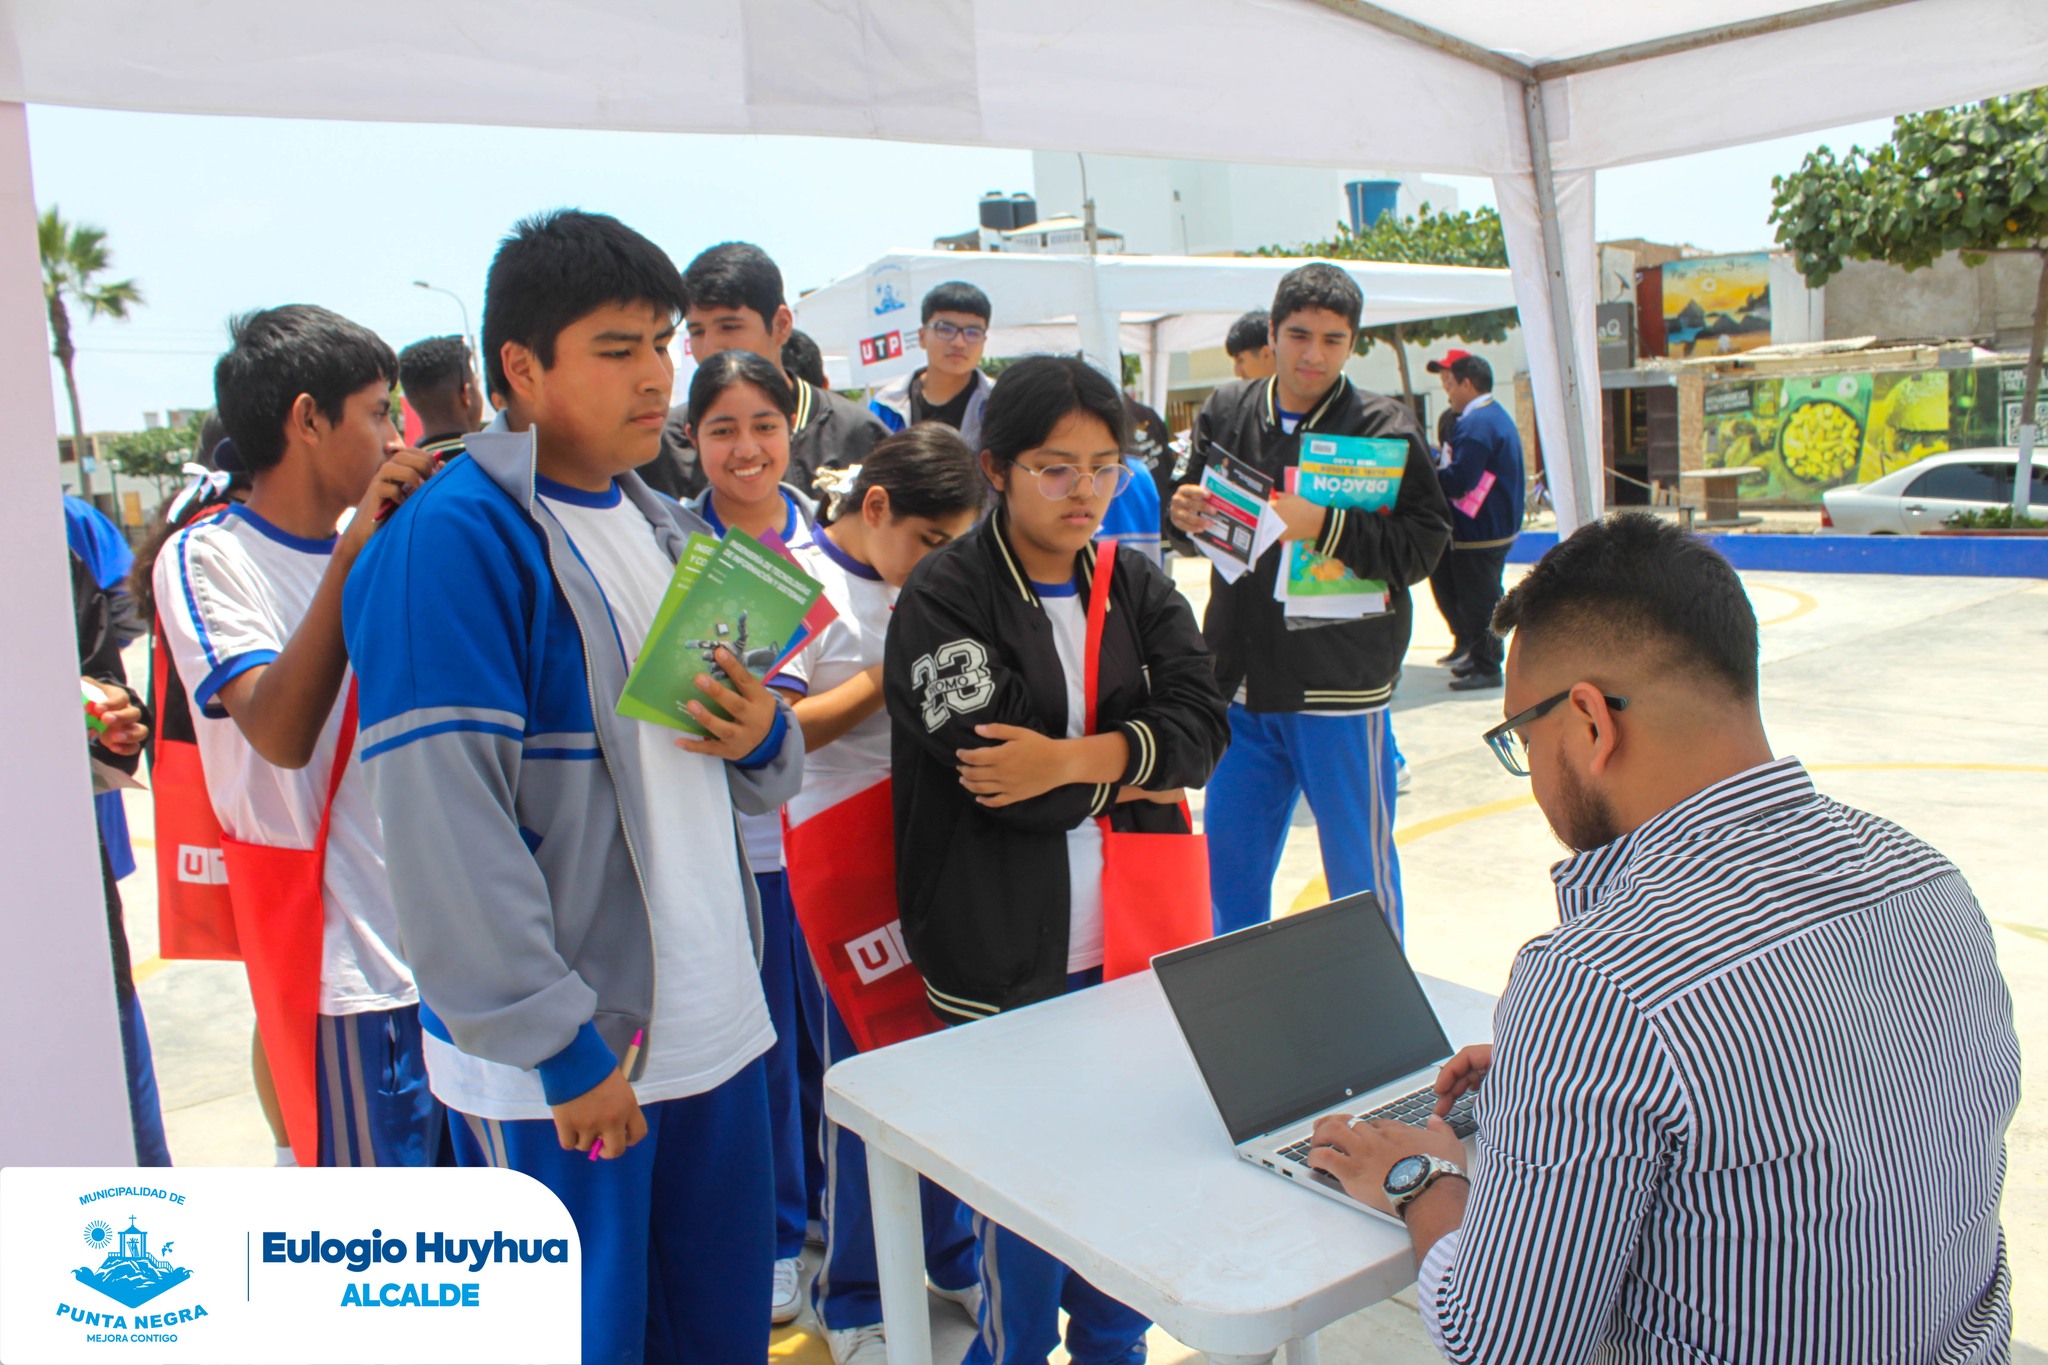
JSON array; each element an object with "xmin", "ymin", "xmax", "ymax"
[{"xmin": 811, "ymin": 978, "xmax": 975, "ymax": 1328}]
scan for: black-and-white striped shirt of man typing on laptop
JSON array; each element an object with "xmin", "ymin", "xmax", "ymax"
[{"xmin": 1417, "ymin": 759, "xmax": 2019, "ymax": 1365}]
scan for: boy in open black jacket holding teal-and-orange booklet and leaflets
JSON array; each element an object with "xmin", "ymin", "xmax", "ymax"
[{"xmin": 1171, "ymin": 262, "xmax": 1450, "ymax": 933}]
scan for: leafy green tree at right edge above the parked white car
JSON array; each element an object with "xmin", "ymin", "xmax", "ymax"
[{"xmin": 1772, "ymin": 88, "xmax": 2048, "ymax": 514}]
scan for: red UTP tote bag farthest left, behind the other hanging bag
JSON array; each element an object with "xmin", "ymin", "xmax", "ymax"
[{"xmin": 150, "ymin": 622, "xmax": 242, "ymax": 962}]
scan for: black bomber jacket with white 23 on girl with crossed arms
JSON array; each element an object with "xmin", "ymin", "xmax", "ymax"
[{"xmin": 883, "ymin": 508, "xmax": 1229, "ymax": 1023}]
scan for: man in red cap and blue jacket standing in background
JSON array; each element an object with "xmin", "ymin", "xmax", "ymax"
[{"xmin": 1430, "ymin": 350, "xmax": 1524, "ymax": 692}]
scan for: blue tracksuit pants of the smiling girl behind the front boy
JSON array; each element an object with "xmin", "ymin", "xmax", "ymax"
[{"xmin": 754, "ymin": 872, "xmax": 825, "ymax": 1261}]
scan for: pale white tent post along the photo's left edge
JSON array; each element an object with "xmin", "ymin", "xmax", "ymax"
[{"xmin": 0, "ymin": 102, "xmax": 141, "ymax": 1166}]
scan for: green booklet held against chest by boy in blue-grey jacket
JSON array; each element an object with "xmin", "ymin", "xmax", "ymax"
[{"xmin": 616, "ymin": 530, "xmax": 821, "ymax": 735}]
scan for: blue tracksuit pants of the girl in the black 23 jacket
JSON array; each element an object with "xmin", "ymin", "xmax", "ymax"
[{"xmin": 961, "ymin": 968, "xmax": 1151, "ymax": 1365}]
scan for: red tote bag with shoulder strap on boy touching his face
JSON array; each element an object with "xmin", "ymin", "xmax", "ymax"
[{"xmin": 221, "ymin": 681, "xmax": 356, "ymax": 1166}]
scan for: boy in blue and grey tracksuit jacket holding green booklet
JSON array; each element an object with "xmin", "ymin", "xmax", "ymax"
[{"xmin": 344, "ymin": 211, "xmax": 803, "ymax": 1365}]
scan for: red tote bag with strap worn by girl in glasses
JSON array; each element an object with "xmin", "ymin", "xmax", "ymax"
[{"xmin": 1085, "ymin": 544, "xmax": 1214, "ymax": 980}]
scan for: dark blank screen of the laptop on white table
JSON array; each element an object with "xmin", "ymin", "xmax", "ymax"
[{"xmin": 1153, "ymin": 892, "xmax": 1450, "ymax": 1142}]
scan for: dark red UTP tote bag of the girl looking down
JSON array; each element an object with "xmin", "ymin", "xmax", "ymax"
[{"xmin": 782, "ymin": 778, "xmax": 942, "ymax": 1052}]
